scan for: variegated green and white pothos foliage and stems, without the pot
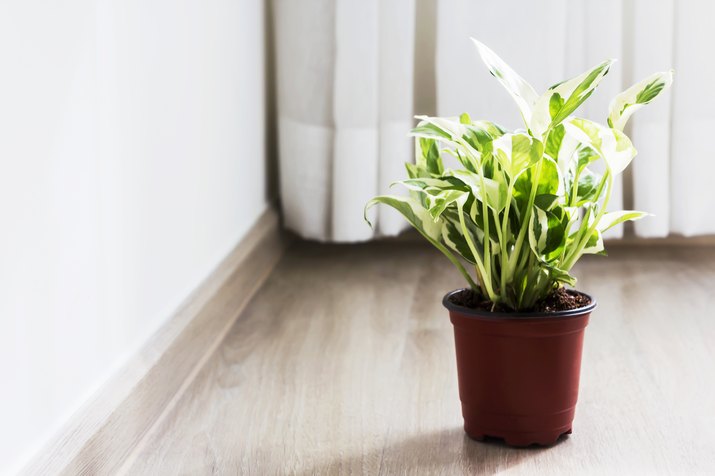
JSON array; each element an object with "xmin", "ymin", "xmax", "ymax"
[{"xmin": 365, "ymin": 39, "xmax": 673, "ymax": 311}]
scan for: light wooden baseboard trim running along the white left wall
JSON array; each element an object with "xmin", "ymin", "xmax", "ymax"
[{"xmin": 22, "ymin": 207, "xmax": 291, "ymax": 475}]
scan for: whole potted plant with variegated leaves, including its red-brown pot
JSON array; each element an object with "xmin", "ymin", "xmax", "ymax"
[{"xmin": 365, "ymin": 39, "xmax": 673, "ymax": 446}]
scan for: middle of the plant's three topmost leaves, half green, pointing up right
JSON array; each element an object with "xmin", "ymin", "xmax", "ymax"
[{"xmin": 529, "ymin": 60, "xmax": 614, "ymax": 138}]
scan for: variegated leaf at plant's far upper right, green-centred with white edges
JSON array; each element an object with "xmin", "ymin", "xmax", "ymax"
[{"xmin": 608, "ymin": 70, "xmax": 673, "ymax": 131}]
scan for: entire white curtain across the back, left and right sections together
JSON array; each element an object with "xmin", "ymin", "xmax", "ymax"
[{"xmin": 273, "ymin": 0, "xmax": 715, "ymax": 241}]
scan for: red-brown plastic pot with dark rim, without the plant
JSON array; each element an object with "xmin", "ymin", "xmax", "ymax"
[{"xmin": 442, "ymin": 290, "xmax": 596, "ymax": 446}]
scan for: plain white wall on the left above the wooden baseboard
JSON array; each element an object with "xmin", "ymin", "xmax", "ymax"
[{"xmin": 0, "ymin": 0, "xmax": 267, "ymax": 473}]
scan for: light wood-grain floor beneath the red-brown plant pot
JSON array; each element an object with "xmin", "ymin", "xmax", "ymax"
[{"xmin": 125, "ymin": 242, "xmax": 715, "ymax": 475}]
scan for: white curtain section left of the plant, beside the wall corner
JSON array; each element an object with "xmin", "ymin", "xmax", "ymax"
[{"xmin": 273, "ymin": 0, "xmax": 414, "ymax": 242}]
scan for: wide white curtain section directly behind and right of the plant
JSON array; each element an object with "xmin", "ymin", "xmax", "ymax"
[{"xmin": 436, "ymin": 0, "xmax": 715, "ymax": 238}]
